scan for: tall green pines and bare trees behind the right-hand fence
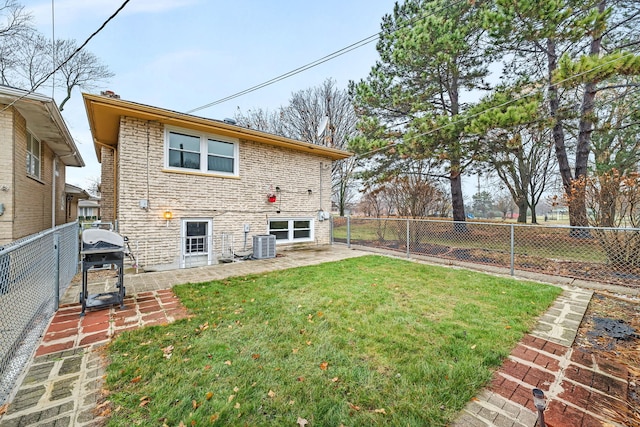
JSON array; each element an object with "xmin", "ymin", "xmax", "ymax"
[{"xmin": 236, "ymin": 0, "xmax": 640, "ymax": 231}]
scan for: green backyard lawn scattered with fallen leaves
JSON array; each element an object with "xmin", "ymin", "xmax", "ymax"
[{"xmin": 107, "ymin": 256, "xmax": 561, "ymax": 427}]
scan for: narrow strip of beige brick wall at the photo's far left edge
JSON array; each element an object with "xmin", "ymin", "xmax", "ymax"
[{"xmin": 0, "ymin": 104, "xmax": 14, "ymax": 245}]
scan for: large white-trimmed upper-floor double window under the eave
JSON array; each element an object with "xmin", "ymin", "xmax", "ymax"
[{"xmin": 165, "ymin": 128, "xmax": 238, "ymax": 176}]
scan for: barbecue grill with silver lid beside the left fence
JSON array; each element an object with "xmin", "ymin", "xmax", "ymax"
[{"xmin": 80, "ymin": 228, "xmax": 125, "ymax": 316}]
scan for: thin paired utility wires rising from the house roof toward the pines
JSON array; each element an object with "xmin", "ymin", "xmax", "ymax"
[{"xmin": 186, "ymin": 0, "xmax": 466, "ymax": 114}]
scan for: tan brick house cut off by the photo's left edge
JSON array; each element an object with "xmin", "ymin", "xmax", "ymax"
[{"xmin": 0, "ymin": 85, "xmax": 84, "ymax": 244}]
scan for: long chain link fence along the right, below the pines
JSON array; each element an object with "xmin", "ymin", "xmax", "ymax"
[{"xmin": 332, "ymin": 217, "xmax": 640, "ymax": 288}]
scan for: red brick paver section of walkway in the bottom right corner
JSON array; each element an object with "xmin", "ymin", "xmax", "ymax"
[{"xmin": 489, "ymin": 335, "xmax": 630, "ymax": 427}]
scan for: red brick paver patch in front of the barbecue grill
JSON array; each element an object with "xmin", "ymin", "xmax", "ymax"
[{"xmin": 36, "ymin": 289, "xmax": 187, "ymax": 356}]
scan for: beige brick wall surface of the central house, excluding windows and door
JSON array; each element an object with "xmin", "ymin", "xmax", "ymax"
[{"xmin": 115, "ymin": 118, "xmax": 331, "ymax": 265}]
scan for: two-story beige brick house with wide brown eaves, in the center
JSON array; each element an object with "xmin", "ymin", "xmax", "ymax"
[{"xmin": 83, "ymin": 94, "xmax": 350, "ymax": 269}]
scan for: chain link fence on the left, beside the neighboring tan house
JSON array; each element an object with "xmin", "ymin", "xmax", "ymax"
[{"xmin": 0, "ymin": 222, "xmax": 79, "ymax": 405}]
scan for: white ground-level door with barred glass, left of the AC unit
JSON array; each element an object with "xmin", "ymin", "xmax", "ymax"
[{"xmin": 180, "ymin": 218, "xmax": 213, "ymax": 268}]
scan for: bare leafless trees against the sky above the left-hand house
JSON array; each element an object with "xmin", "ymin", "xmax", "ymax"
[{"xmin": 0, "ymin": 0, "xmax": 113, "ymax": 111}]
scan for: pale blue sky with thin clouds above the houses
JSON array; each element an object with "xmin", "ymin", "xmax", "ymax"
[{"xmin": 21, "ymin": 0, "xmax": 394, "ymax": 187}]
